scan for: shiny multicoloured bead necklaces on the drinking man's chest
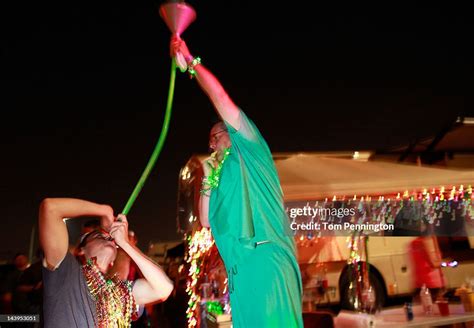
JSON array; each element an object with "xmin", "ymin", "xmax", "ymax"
[{"xmin": 82, "ymin": 258, "xmax": 137, "ymax": 328}]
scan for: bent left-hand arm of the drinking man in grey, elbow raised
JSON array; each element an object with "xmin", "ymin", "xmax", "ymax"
[{"xmin": 39, "ymin": 198, "xmax": 114, "ymax": 269}]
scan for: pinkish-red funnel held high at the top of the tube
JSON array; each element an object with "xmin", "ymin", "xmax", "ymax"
[{"xmin": 160, "ymin": 2, "xmax": 196, "ymax": 72}]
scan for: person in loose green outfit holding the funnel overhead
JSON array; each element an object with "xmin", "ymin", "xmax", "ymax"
[{"xmin": 171, "ymin": 37, "xmax": 303, "ymax": 328}]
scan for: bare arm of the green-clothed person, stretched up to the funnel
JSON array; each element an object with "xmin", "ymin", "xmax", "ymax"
[{"xmin": 170, "ymin": 36, "xmax": 240, "ymax": 130}]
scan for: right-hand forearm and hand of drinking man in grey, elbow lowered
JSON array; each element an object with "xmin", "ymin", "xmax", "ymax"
[{"xmin": 110, "ymin": 215, "xmax": 173, "ymax": 304}]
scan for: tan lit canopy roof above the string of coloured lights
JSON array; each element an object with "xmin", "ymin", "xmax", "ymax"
[{"xmin": 275, "ymin": 154, "xmax": 474, "ymax": 201}]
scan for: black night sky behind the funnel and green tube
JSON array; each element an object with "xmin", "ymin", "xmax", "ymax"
[{"xmin": 0, "ymin": 0, "xmax": 474, "ymax": 254}]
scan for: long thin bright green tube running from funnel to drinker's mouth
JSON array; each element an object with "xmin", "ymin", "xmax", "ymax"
[{"xmin": 122, "ymin": 58, "xmax": 176, "ymax": 215}]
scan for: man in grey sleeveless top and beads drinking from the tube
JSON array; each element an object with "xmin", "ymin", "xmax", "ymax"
[{"xmin": 39, "ymin": 198, "xmax": 173, "ymax": 328}]
